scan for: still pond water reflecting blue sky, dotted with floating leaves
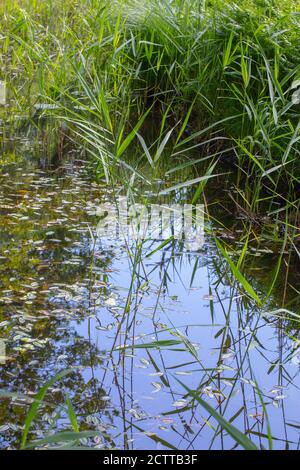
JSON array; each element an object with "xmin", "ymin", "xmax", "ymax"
[{"xmin": 0, "ymin": 146, "xmax": 300, "ymax": 450}]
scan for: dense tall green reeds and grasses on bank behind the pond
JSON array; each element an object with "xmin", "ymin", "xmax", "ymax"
[{"xmin": 0, "ymin": 0, "xmax": 300, "ymax": 202}]
